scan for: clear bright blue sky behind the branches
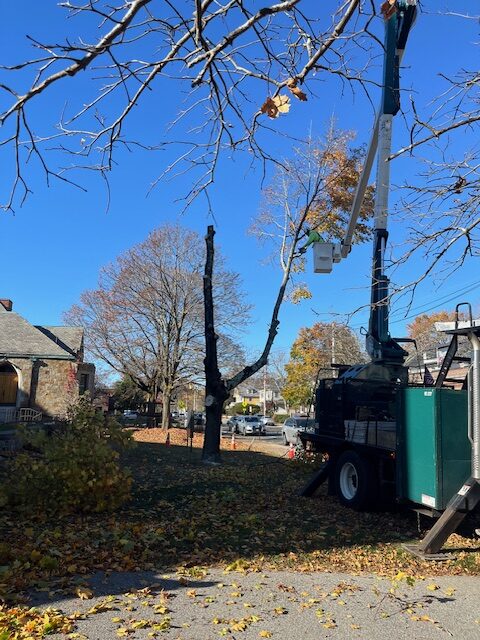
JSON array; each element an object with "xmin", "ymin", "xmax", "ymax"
[{"xmin": 0, "ymin": 0, "xmax": 479, "ymax": 360}]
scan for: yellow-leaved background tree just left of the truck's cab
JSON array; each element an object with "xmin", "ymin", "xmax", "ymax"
[{"xmin": 282, "ymin": 322, "xmax": 365, "ymax": 408}]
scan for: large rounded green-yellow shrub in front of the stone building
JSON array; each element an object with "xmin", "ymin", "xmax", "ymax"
[{"xmin": 2, "ymin": 399, "xmax": 131, "ymax": 514}]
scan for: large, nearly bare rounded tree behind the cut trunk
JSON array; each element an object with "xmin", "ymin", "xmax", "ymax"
[{"xmin": 67, "ymin": 225, "xmax": 248, "ymax": 427}]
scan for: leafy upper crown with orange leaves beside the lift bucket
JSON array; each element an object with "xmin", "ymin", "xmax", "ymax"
[{"xmin": 250, "ymin": 127, "xmax": 374, "ymax": 303}]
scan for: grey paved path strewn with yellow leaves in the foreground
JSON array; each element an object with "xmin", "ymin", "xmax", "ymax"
[{"xmin": 42, "ymin": 569, "xmax": 480, "ymax": 640}]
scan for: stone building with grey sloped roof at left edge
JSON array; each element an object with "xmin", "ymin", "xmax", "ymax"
[{"xmin": 0, "ymin": 299, "xmax": 95, "ymax": 422}]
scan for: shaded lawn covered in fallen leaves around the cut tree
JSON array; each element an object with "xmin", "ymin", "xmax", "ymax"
[{"xmin": 0, "ymin": 430, "xmax": 480, "ymax": 597}]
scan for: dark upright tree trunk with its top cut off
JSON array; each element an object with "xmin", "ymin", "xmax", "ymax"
[{"xmin": 202, "ymin": 225, "xmax": 228, "ymax": 464}]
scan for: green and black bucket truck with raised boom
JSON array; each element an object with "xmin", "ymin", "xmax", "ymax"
[{"xmin": 299, "ymin": 0, "xmax": 480, "ymax": 557}]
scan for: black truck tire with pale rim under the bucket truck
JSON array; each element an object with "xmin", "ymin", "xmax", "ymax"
[{"xmin": 335, "ymin": 451, "xmax": 377, "ymax": 511}]
